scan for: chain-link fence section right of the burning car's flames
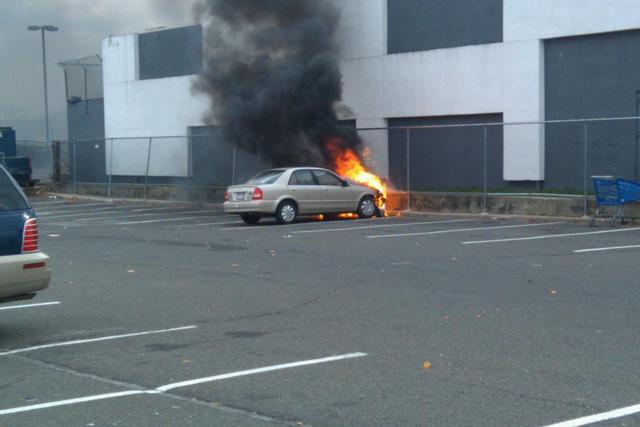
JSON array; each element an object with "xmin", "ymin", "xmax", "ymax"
[{"xmin": 378, "ymin": 117, "xmax": 640, "ymax": 215}]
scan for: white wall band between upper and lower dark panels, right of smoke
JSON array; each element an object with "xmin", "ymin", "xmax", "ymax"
[{"xmin": 341, "ymin": 43, "xmax": 503, "ymax": 118}]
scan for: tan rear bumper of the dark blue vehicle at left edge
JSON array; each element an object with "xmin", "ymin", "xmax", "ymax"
[{"xmin": 0, "ymin": 252, "xmax": 51, "ymax": 300}]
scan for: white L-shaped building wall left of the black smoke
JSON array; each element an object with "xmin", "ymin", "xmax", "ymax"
[{"xmin": 102, "ymin": 35, "xmax": 208, "ymax": 177}]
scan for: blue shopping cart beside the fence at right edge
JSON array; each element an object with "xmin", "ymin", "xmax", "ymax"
[{"xmin": 591, "ymin": 176, "xmax": 640, "ymax": 226}]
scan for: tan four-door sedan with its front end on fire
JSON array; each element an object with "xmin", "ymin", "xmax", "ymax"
[{"xmin": 224, "ymin": 167, "xmax": 379, "ymax": 224}]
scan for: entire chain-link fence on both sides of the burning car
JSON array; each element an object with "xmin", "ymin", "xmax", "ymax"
[{"xmin": 33, "ymin": 117, "xmax": 640, "ymax": 214}]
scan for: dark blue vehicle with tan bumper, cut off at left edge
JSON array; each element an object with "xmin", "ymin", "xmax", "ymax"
[{"xmin": 0, "ymin": 166, "xmax": 51, "ymax": 303}]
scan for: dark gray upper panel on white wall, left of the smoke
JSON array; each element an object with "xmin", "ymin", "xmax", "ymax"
[{"xmin": 138, "ymin": 25, "xmax": 202, "ymax": 80}]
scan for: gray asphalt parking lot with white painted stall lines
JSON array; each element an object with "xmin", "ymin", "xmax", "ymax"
[{"xmin": 0, "ymin": 198, "xmax": 640, "ymax": 427}]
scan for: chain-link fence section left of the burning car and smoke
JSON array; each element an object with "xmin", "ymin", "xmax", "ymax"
[{"xmin": 60, "ymin": 133, "xmax": 269, "ymax": 202}]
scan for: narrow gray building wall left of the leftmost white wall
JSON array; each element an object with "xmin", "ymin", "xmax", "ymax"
[{"xmin": 67, "ymin": 98, "xmax": 107, "ymax": 182}]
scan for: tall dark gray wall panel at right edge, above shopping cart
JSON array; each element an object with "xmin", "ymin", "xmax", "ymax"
[{"xmin": 545, "ymin": 31, "xmax": 640, "ymax": 190}]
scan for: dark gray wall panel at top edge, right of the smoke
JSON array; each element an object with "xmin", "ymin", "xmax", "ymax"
[{"xmin": 387, "ymin": 0, "xmax": 502, "ymax": 53}]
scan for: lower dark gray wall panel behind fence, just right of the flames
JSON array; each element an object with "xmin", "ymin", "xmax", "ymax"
[{"xmin": 388, "ymin": 114, "xmax": 505, "ymax": 191}]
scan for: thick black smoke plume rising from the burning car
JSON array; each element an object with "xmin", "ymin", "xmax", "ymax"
[{"xmin": 195, "ymin": 0, "xmax": 360, "ymax": 167}]
